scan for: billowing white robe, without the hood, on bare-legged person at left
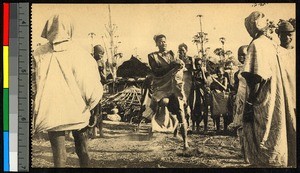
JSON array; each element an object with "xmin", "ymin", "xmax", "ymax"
[{"xmin": 33, "ymin": 41, "xmax": 103, "ymax": 132}]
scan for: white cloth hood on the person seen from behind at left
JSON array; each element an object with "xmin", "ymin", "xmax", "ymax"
[{"xmin": 41, "ymin": 14, "xmax": 74, "ymax": 43}]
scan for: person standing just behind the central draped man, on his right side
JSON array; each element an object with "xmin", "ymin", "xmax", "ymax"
[{"xmin": 178, "ymin": 43, "xmax": 194, "ymax": 128}]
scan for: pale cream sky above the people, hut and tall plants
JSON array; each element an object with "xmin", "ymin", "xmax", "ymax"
[{"xmin": 32, "ymin": 3, "xmax": 296, "ymax": 62}]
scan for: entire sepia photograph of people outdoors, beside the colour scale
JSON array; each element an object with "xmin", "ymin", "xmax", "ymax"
[{"xmin": 31, "ymin": 3, "xmax": 297, "ymax": 168}]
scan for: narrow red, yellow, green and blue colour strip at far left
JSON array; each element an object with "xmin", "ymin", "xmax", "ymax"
[{"xmin": 3, "ymin": 3, "xmax": 10, "ymax": 171}]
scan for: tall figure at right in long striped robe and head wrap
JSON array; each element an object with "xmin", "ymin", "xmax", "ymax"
[{"xmin": 242, "ymin": 12, "xmax": 296, "ymax": 167}]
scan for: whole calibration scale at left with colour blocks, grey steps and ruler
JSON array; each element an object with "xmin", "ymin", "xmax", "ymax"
[{"xmin": 2, "ymin": 3, "xmax": 23, "ymax": 172}]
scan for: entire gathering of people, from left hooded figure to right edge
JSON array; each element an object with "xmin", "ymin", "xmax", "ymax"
[{"xmin": 32, "ymin": 11, "xmax": 296, "ymax": 167}]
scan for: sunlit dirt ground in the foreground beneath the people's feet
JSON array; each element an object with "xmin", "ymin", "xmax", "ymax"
[{"xmin": 32, "ymin": 116, "xmax": 248, "ymax": 168}]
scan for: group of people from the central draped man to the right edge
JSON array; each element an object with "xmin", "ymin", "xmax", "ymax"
[{"xmin": 145, "ymin": 11, "xmax": 296, "ymax": 167}]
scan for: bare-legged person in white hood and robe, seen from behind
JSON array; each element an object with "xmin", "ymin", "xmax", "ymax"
[{"xmin": 33, "ymin": 15, "xmax": 103, "ymax": 167}]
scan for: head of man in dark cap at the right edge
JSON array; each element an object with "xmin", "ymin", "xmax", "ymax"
[{"xmin": 276, "ymin": 21, "xmax": 295, "ymax": 49}]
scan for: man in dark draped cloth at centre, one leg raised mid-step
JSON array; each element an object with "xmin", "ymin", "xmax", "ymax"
[{"xmin": 148, "ymin": 34, "xmax": 189, "ymax": 149}]
